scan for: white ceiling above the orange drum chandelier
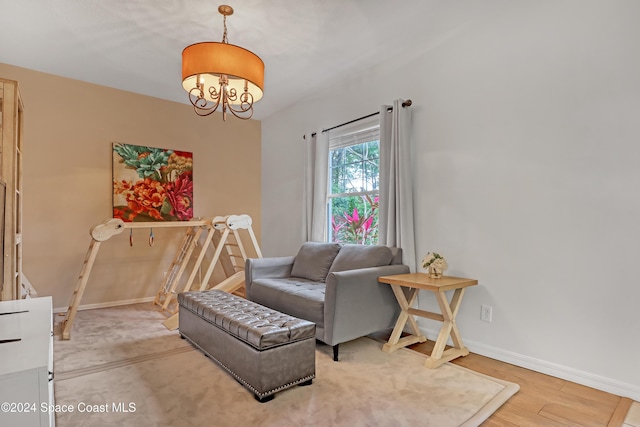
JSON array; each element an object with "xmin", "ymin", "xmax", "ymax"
[{"xmin": 0, "ymin": 0, "xmax": 486, "ymax": 120}]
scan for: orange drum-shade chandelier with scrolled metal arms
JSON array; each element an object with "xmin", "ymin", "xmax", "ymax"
[{"xmin": 182, "ymin": 5, "xmax": 264, "ymax": 120}]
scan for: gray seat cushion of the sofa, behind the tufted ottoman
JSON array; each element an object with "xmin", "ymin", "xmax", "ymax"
[{"xmin": 247, "ymin": 278, "xmax": 325, "ymax": 327}]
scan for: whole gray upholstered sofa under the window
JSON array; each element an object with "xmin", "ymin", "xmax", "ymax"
[{"xmin": 245, "ymin": 242, "xmax": 409, "ymax": 360}]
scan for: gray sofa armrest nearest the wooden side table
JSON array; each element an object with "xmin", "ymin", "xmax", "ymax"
[{"xmin": 324, "ymin": 264, "xmax": 409, "ymax": 345}]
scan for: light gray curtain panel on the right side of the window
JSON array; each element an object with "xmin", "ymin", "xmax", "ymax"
[{"xmin": 378, "ymin": 99, "xmax": 416, "ymax": 272}]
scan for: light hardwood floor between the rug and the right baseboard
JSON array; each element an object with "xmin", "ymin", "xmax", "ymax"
[{"xmin": 373, "ymin": 331, "xmax": 632, "ymax": 427}]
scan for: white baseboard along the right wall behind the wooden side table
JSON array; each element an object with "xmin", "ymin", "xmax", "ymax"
[{"xmin": 420, "ymin": 328, "xmax": 640, "ymax": 401}]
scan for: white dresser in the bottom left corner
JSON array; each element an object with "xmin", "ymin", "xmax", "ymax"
[{"xmin": 0, "ymin": 297, "xmax": 55, "ymax": 427}]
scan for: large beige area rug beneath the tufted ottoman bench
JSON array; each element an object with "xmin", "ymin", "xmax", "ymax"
[{"xmin": 54, "ymin": 304, "xmax": 519, "ymax": 427}]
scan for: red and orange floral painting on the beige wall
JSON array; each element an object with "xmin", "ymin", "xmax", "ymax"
[{"xmin": 113, "ymin": 143, "xmax": 193, "ymax": 222}]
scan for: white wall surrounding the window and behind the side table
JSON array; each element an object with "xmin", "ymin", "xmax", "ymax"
[{"xmin": 262, "ymin": 0, "xmax": 640, "ymax": 400}]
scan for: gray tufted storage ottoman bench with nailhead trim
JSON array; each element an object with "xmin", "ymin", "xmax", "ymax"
[{"xmin": 178, "ymin": 289, "xmax": 316, "ymax": 402}]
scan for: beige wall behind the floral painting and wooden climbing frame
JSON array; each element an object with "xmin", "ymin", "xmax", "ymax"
[{"xmin": 0, "ymin": 63, "xmax": 261, "ymax": 308}]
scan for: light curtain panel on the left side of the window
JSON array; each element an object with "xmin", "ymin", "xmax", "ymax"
[{"xmin": 303, "ymin": 131, "xmax": 329, "ymax": 242}]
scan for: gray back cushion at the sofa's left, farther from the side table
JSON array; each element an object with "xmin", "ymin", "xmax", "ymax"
[{"xmin": 291, "ymin": 242, "xmax": 340, "ymax": 282}]
